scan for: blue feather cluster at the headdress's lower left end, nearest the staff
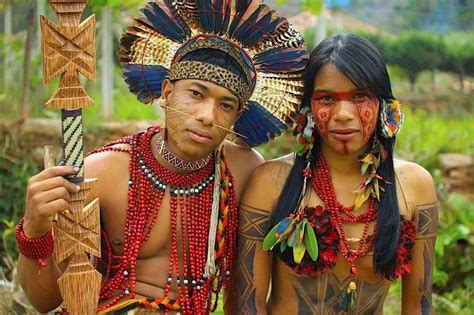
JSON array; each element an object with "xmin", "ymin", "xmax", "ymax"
[{"xmin": 123, "ymin": 64, "xmax": 168, "ymax": 103}]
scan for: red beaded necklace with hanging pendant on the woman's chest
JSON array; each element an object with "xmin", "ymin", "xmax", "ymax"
[{"xmin": 312, "ymin": 153, "xmax": 377, "ymax": 308}]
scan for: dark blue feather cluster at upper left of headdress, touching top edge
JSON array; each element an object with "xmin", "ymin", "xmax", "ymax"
[{"xmin": 139, "ymin": 1, "xmax": 191, "ymax": 43}]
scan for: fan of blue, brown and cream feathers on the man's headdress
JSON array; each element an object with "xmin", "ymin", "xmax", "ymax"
[{"xmin": 120, "ymin": 0, "xmax": 308, "ymax": 147}]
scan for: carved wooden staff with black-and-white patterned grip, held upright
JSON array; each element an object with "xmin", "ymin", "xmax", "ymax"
[{"xmin": 41, "ymin": 0, "xmax": 102, "ymax": 315}]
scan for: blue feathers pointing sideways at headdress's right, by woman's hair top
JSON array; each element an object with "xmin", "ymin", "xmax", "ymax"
[{"xmin": 254, "ymin": 47, "xmax": 308, "ymax": 73}]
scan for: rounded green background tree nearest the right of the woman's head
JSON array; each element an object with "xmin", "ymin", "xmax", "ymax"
[{"xmin": 386, "ymin": 31, "xmax": 445, "ymax": 91}]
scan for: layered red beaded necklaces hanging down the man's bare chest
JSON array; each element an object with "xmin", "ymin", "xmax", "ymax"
[{"xmin": 89, "ymin": 127, "xmax": 237, "ymax": 314}]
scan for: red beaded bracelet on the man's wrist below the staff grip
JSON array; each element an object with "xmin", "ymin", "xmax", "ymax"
[{"xmin": 15, "ymin": 219, "xmax": 54, "ymax": 269}]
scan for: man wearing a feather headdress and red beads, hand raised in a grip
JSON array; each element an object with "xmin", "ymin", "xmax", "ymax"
[{"xmin": 17, "ymin": 0, "xmax": 307, "ymax": 314}]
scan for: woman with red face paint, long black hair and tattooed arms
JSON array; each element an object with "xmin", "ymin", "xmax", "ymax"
[{"xmin": 237, "ymin": 34, "xmax": 437, "ymax": 314}]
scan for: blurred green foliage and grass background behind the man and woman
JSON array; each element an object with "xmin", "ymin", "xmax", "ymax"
[{"xmin": 0, "ymin": 0, "xmax": 474, "ymax": 314}]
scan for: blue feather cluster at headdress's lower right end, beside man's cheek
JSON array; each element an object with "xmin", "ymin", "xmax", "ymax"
[{"xmin": 234, "ymin": 101, "xmax": 287, "ymax": 147}]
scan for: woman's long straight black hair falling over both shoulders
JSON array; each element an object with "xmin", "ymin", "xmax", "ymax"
[{"xmin": 270, "ymin": 34, "xmax": 400, "ymax": 279}]
